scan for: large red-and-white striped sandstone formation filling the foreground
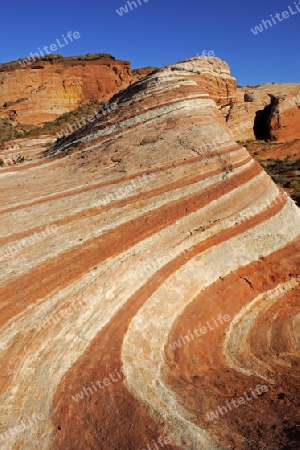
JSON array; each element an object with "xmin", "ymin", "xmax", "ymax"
[{"xmin": 0, "ymin": 57, "xmax": 300, "ymax": 450}]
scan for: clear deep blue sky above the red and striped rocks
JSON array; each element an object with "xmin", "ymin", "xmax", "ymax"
[{"xmin": 0, "ymin": 0, "xmax": 300, "ymax": 85}]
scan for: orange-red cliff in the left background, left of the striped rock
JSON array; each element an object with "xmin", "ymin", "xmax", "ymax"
[{"xmin": 0, "ymin": 57, "xmax": 153, "ymax": 125}]
